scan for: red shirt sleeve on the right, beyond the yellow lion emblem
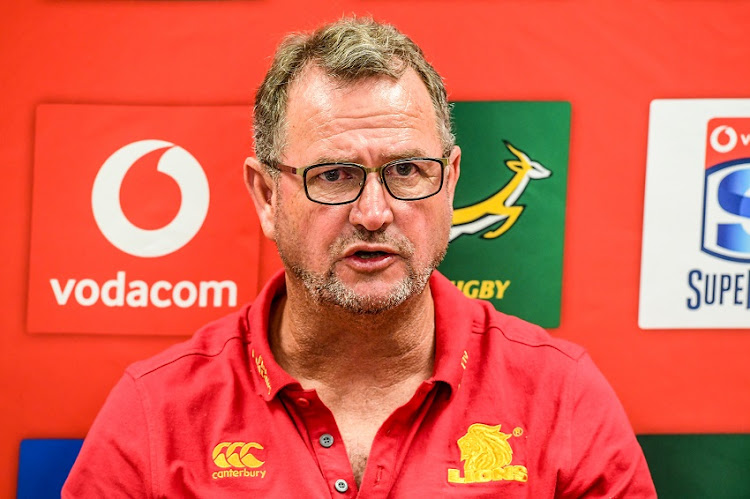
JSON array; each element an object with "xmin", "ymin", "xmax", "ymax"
[{"xmin": 557, "ymin": 354, "xmax": 656, "ymax": 498}]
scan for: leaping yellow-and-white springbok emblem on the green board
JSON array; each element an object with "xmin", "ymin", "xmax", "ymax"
[{"xmin": 450, "ymin": 140, "xmax": 552, "ymax": 241}]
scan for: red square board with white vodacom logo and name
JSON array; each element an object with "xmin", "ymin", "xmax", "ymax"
[{"xmin": 27, "ymin": 104, "xmax": 259, "ymax": 335}]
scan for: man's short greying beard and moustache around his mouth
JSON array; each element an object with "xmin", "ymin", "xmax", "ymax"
[{"xmin": 279, "ymin": 230, "xmax": 447, "ymax": 315}]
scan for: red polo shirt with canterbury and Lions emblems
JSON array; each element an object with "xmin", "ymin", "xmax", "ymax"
[{"xmin": 63, "ymin": 272, "xmax": 656, "ymax": 499}]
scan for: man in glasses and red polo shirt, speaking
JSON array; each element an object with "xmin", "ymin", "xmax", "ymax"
[{"xmin": 63, "ymin": 19, "xmax": 655, "ymax": 498}]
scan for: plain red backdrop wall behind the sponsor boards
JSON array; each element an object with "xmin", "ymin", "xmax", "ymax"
[{"xmin": 0, "ymin": 0, "xmax": 750, "ymax": 496}]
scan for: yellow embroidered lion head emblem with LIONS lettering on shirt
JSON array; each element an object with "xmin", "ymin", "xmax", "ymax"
[{"xmin": 448, "ymin": 423, "xmax": 529, "ymax": 483}]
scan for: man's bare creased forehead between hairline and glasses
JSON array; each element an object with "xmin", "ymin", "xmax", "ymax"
[{"xmin": 282, "ymin": 66, "xmax": 442, "ymax": 164}]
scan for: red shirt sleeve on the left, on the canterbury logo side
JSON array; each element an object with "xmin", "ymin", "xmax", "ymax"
[{"xmin": 62, "ymin": 374, "xmax": 151, "ymax": 499}]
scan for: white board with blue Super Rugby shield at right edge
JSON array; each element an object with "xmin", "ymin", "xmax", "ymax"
[{"xmin": 638, "ymin": 99, "xmax": 750, "ymax": 329}]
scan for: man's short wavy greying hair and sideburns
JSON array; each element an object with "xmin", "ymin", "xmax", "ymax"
[{"xmin": 254, "ymin": 18, "xmax": 456, "ymax": 173}]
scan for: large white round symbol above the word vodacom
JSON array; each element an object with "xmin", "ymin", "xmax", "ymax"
[{"xmin": 91, "ymin": 140, "xmax": 209, "ymax": 258}]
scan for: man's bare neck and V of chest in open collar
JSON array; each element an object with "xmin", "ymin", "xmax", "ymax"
[{"xmin": 269, "ymin": 274, "xmax": 435, "ymax": 485}]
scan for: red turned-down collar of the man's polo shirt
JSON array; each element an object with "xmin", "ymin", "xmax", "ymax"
[{"xmin": 247, "ymin": 270, "xmax": 472, "ymax": 401}]
